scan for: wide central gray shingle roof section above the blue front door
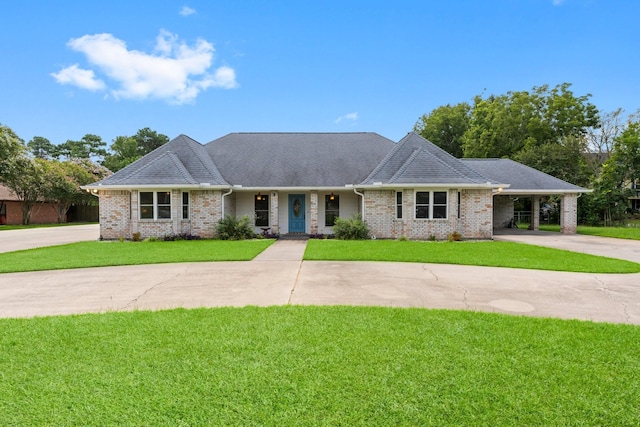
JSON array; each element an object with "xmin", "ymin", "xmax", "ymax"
[{"xmin": 205, "ymin": 132, "xmax": 395, "ymax": 187}]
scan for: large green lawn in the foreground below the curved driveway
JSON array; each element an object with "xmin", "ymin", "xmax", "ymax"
[{"xmin": 0, "ymin": 306, "xmax": 640, "ymax": 426}]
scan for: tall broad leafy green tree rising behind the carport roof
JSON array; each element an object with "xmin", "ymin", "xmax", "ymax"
[{"xmin": 464, "ymin": 83, "xmax": 599, "ymax": 158}]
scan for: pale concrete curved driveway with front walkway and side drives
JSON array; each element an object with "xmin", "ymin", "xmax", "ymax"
[{"xmin": 0, "ymin": 226, "xmax": 640, "ymax": 324}]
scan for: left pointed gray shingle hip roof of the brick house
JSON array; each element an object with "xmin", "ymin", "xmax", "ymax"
[{"xmin": 101, "ymin": 135, "xmax": 228, "ymax": 186}]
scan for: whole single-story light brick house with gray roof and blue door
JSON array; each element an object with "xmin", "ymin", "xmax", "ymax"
[{"xmin": 83, "ymin": 133, "xmax": 589, "ymax": 239}]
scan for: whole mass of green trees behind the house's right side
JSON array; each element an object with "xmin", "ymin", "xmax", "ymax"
[{"xmin": 414, "ymin": 83, "xmax": 640, "ymax": 225}]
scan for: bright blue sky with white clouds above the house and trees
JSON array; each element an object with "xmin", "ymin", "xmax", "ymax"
[{"xmin": 0, "ymin": 0, "xmax": 640, "ymax": 148}]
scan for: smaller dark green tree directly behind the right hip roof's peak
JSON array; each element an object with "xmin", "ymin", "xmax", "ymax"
[{"xmin": 413, "ymin": 102, "xmax": 471, "ymax": 157}]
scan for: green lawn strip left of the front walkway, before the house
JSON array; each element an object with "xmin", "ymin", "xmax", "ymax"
[{"xmin": 0, "ymin": 239, "xmax": 273, "ymax": 273}]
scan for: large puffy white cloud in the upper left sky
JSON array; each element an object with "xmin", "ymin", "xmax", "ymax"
[{"xmin": 54, "ymin": 30, "xmax": 238, "ymax": 104}]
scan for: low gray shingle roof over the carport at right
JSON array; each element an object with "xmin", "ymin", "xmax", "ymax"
[{"xmin": 462, "ymin": 159, "xmax": 590, "ymax": 193}]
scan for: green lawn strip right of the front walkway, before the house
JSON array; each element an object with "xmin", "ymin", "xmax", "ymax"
[{"xmin": 304, "ymin": 240, "xmax": 640, "ymax": 273}]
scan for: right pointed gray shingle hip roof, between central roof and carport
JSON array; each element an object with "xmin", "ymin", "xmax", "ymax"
[{"xmin": 363, "ymin": 132, "xmax": 504, "ymax": 185}]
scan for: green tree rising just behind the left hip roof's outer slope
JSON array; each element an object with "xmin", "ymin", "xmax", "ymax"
[{"xmin": 102, "ymin": 128, "xmax": 169, "ymax": 172}]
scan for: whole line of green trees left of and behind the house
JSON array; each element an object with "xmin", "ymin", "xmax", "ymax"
[{"xmin": 0, "ymin": 124, "xmax": 169, "ymax": 225}]
